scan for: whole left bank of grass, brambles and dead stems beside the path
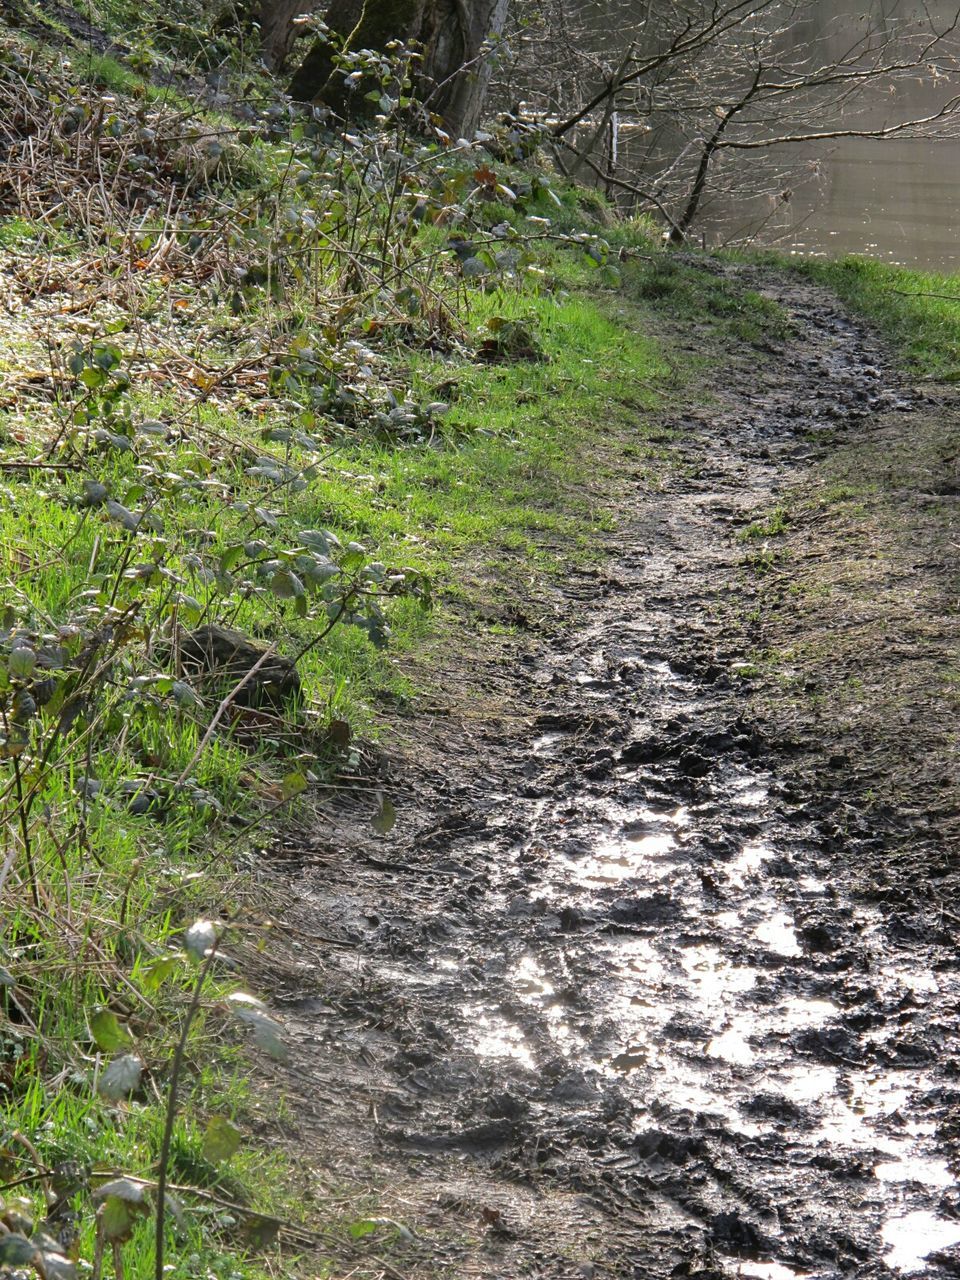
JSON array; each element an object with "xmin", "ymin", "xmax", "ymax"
[{"xmin": 0, "ymin": 10, "xmax": 666, "ymax": 1280}]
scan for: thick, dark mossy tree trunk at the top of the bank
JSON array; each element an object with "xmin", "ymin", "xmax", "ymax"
[{"xmin": 289, "ymin": 0, "xmax": 508, "ymax": 137}]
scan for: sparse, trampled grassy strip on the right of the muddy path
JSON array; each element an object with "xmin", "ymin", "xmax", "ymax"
[{"xmin": 740, "ymin": 250, "xmax": 960, "ymax": 896}]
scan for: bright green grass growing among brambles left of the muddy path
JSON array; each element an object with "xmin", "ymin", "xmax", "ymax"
[{"xmin": 0, "ymin": 186, "xmax": 669, "ymax": 1280}]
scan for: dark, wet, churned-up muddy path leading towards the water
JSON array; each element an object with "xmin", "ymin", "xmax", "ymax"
[{"xmin": 267, "ymin": 276, "xmax": 960, "ymax": 1280}]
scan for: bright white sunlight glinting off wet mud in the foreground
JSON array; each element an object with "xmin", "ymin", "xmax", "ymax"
[{"xmin": 465, "ymin": 711, "xmax": 960, "ymax": 1280}]
